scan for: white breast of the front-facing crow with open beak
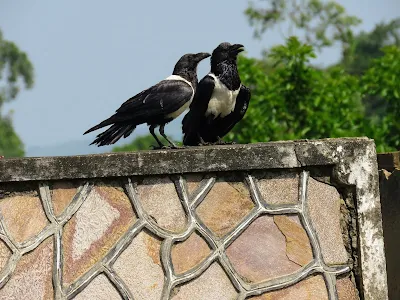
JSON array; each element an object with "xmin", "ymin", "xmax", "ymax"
[{"xmin": 206, "ymin": 73, "xmax": 240, "ymax": 119}]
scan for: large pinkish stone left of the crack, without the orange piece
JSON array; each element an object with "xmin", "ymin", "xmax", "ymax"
[{"xmin": 226, "ymin": 216, "xmax": 300, "ymax": 283}]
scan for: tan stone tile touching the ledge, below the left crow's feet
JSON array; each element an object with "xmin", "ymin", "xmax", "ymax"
[{"xmin": 137, "ymin": 177, "xmax": 187, "ymax": 232}]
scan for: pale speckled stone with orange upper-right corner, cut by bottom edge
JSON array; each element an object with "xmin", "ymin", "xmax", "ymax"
[{"xmin": 114, "ymin": 231, "xmax": 164, "ymax": 300}]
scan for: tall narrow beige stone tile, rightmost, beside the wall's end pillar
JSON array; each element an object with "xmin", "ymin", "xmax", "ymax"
[{"xmin": 307, "ymin": 178, "xmax": 348, "ymax": 265}]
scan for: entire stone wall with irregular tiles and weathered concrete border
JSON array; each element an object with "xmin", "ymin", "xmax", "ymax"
[{"xmin": 0, "ymin": 139, "xmax": 387, "ymax": 300}]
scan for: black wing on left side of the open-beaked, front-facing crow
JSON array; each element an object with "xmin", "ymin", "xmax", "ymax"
[{"xmin": 182, "ymin": 75, "xmax": 215, "ymax": 145}]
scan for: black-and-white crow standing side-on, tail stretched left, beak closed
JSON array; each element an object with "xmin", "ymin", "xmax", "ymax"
[{"xmin": 84, "ymin": 52, "xmax": 211, "ymax": 148}]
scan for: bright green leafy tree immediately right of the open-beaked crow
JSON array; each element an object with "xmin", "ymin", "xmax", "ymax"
[{"xmin": 230, "ymin": 37, "xmax": 363, "ymax": 142}]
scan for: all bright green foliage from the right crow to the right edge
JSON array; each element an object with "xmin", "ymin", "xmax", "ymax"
[{"xmin": 229, "ymin": 37, "xmax": 400, "ymax": 151}]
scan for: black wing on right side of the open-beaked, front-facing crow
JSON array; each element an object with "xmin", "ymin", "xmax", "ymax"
[{"xmin": 218, "ymin": 85, "xmax": 251, "ymax": 137}]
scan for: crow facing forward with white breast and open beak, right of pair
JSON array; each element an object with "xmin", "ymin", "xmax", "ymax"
[{"xmin": 182, "ymin": 43, "xmax": 251, "ymax": 146}]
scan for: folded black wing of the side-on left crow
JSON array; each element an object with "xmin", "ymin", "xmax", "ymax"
[{"xmin": 84, "ymin": 80, "xmax": 193, "ymax": 134}]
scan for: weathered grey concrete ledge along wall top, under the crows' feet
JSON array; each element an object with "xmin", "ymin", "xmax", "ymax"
[{"xmin": 0, "ymin": 138, "xmax": 376, "ymax": 182}]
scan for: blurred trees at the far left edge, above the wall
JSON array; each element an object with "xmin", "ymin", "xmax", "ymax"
[{"xmin": 0, "ymin": 30, "xmax": 34, "ymax": 157}]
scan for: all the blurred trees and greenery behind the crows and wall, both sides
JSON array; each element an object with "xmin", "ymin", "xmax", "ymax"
[{"xmin": 0, "ymin": 0, "xmax": 400, "ymax": 157}]
